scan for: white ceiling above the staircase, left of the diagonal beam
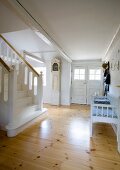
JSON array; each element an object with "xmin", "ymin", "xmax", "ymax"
[{"xmin": 0, "ymin": 0, "xmax": 56, "ymax": 56}]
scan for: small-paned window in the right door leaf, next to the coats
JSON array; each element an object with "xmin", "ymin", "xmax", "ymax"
[{"xmin": 89, "ymin": 69, "xmax": 101, "ymax": 80}]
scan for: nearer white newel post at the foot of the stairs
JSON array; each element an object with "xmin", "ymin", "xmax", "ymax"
[{"xmin": 8, "ymin": 66, "xmax": 17, "ymax": 128}]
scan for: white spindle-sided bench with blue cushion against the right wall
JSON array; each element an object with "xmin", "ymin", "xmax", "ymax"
[{"xmin": 90, "ymin": 96, "xmax": 119, "ymax": 137}]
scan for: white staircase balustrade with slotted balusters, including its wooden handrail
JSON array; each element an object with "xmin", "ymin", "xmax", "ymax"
[{"xmin": 0, "ymin": 36, "xmax": 43, "ymax": 136}]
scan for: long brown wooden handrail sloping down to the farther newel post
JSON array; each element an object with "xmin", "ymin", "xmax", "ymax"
[{"xmin": 0, "ymin": 34, "xmax": 39, "ymax": 76}]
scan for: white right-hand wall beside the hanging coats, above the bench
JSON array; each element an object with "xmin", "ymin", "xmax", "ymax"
[{"xmin": 106, "ymin": 30, "xmax": 120, "ymax": 97}]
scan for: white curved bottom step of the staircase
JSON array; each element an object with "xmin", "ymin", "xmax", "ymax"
[{"xmin": 6, "ymin": 108, "xmax": 47, "ymax": 137}]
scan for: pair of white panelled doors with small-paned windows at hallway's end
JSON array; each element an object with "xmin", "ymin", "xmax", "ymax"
[{"xmin": 71, "ymin": 66, "xmax": 103, "ymax": 104}]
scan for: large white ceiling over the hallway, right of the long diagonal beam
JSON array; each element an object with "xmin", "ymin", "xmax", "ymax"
[{"xmin": 14, "ymin": 0, "xmax": 120, "ymax": 60}]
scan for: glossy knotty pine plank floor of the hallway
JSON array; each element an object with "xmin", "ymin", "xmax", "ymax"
[{"xmin": 0, "ymin": 105, "xmax": 120, "ymax": 170}]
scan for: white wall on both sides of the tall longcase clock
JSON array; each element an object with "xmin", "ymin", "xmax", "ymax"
[{"xmin": 44, "ymin": 53, "xmax": 71, "ymax": 105}]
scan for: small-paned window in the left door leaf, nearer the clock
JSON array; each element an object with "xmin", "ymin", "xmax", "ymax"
[{"xmin": 74, "ymin": 68, "xmax": 85, "ymax": 80}]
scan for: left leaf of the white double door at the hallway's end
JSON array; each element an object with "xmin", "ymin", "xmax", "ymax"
[{"xmin": 72, "ymin": 67, "xmax": 87, "ymax": 104}]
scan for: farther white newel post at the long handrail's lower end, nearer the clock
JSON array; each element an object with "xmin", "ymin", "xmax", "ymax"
[{"xmin": 37, "ymin": 72, "xmax": 43, "ymax": 110}]
